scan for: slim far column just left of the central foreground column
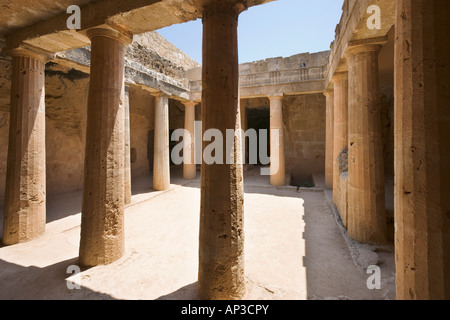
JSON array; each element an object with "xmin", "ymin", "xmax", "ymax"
[{"xmin": 183, "ymin": 101, "xmax": 197, "ymax": 180}]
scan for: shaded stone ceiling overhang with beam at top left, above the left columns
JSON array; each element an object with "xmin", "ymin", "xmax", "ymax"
[{"xmin": 0, "ymin": 0, "xmax": 274, "ymax": 53}]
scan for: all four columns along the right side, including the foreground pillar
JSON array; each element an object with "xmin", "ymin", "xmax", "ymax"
[{"xmin": 325, "ymin": 0, "xmax": 450, "ymax": 299}]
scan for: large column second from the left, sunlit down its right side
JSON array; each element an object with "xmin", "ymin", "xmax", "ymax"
[{"xmin": 80, "ymin": 28, "xmax": 131, "ymax": 266}]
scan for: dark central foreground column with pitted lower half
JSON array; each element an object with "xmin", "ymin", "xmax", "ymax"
[{"xmin": 198, "ymin": 0, "xmax": 246, "ymax": 299}]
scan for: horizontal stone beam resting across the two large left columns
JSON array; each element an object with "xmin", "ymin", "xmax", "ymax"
[{"xmin": 5, "ymin": 0, "xmax": 274, "ymax": 53}]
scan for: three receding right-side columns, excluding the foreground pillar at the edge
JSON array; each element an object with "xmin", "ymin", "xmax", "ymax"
[{"xmin": 325, "ymin": 44, "xmax": 387, "ymax": 244}]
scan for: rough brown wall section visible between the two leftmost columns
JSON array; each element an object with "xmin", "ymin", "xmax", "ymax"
[{"xmin": 45, "ymin": 72, "xmax": 89, "ymax": 195}]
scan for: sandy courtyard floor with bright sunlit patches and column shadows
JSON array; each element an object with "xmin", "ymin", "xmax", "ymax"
[{"xmin": 0, "ymin": 170, "xmax": 395, "ymax": 300}]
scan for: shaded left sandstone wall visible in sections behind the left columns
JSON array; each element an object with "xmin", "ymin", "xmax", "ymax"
[{"xmin": 0, "ymin": 60, "xmax": 158, "ymax": 205}]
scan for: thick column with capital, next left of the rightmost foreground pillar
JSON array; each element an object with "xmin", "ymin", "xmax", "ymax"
[{"xmin": 347, "ymin": 44, "xmax": 387, "ymax": 244}]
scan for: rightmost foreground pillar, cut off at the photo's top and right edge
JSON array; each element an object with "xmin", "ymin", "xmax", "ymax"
[{"xmin": 394, "ymin": 0, "xmax": 450, "ymax": 300}]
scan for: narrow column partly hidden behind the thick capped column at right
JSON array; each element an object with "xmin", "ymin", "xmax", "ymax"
[{"xmin": 333, "ymin": 72, "xmax": 348, "ymax": 208}]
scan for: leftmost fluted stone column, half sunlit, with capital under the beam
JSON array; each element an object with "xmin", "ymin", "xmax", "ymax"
[{"xmin": 3, "ymin": 49, "xmax": 46, "ymax": 245}]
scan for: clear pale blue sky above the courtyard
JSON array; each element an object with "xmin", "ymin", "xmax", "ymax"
[{"xmin": 158, "ymin": 0, "xmax": 344, "ymax": 63}]
